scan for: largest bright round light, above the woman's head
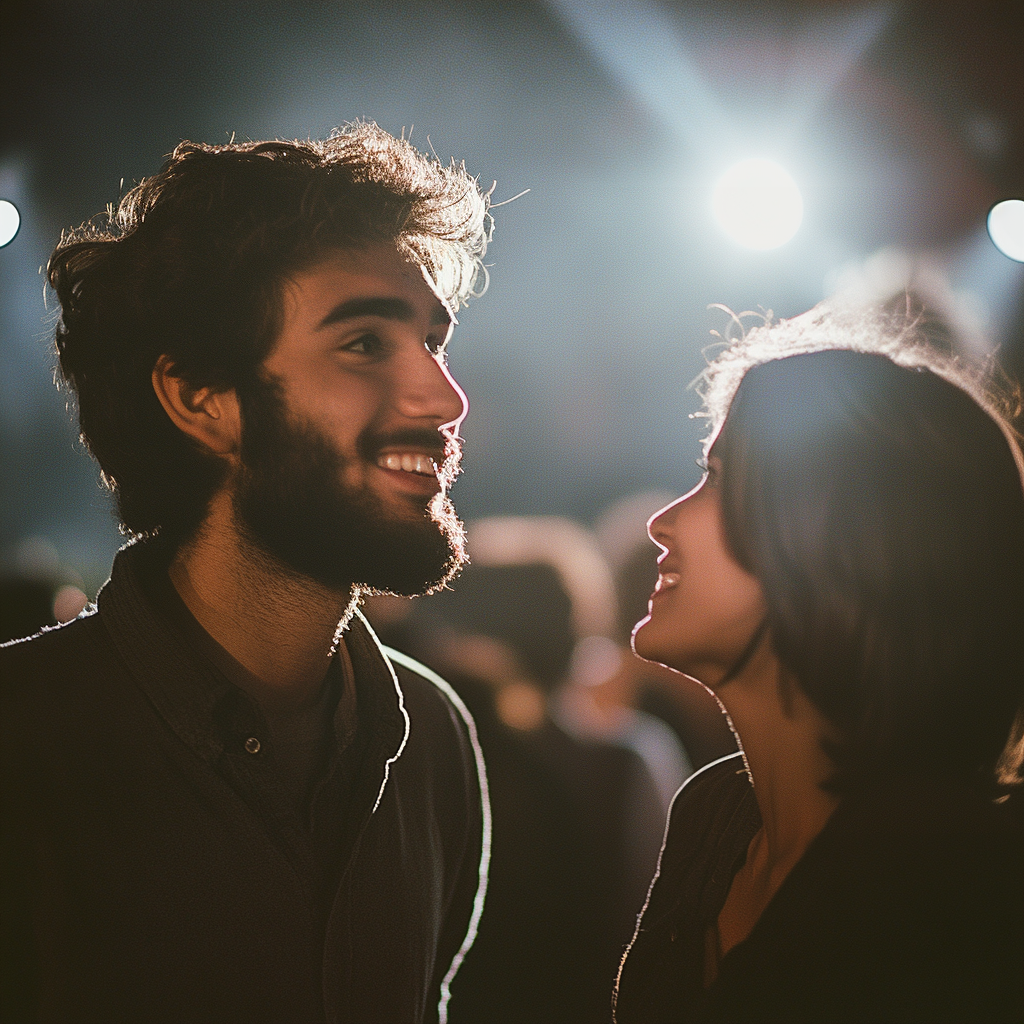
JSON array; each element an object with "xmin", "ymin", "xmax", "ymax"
[{"xmin": 711, "ymin": 158, "xmax": 804, "ymax": 250}]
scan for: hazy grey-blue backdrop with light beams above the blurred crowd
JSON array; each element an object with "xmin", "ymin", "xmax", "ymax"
[{"xmin": 0, "ymin": 0, "xmax": 1024, "ymax": 596}]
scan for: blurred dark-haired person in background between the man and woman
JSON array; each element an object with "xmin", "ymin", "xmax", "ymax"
[{"xmin": 368, "ymin": 516, "xmax": 663, "ymax": 1024}]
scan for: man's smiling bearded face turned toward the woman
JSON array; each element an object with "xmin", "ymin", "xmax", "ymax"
[{"xmin": 233, "ymin": 245, "xmax": 467, "ymax": 594}]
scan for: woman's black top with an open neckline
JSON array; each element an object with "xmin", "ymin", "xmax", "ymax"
[{"xmin": 615, "ymin": 754, "xmax": 1024, "ymax": 1024}]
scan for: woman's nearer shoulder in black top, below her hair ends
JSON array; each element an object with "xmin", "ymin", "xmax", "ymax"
[{"xmin": 720, "ymin": 778, "xmax": 1024, "ymax": 1021}]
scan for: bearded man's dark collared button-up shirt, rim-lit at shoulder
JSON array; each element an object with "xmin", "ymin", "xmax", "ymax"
[{"xmin": 0, "ymin": 544, "xmax": 488, "ymax": 1024}]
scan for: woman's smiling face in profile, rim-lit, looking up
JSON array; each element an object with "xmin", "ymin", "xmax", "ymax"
[{"xmin": 633, "ymin": 455, "xmax": 766, "ymax": 688}]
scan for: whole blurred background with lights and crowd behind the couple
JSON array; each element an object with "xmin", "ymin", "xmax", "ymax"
[{"xmin": 0, "ymin": 0, "xmax": 1024, "ymax": 1024}]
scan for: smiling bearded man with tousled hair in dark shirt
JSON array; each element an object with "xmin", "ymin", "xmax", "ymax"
[{"xmin": 0, "ymin": 124, "xmax": 489, "ymax": 1022}]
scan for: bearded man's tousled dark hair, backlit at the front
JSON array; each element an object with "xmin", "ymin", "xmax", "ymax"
[{"xmin": 47, "ymin": 123, "xmax": 490, "ymax": 540}]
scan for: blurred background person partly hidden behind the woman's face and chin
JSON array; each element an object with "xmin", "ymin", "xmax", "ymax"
[{"xmin": 592, "ymin": 492, "xmax": 736, "ymax": 774}]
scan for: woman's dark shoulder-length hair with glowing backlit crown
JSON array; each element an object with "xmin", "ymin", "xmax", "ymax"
[{"xmin": 706, "ymin": 307, "xmax": 1024, "ymax": 788}]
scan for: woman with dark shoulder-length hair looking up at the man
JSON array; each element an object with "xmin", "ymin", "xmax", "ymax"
[{"xmin": 615, "ymin": 307, "xmax": 1024, "ymax": 1024}]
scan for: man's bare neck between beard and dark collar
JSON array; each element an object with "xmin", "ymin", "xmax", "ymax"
[{"xmin": 169, "ymin": 499, "xmax": 352, "ymax": 711}]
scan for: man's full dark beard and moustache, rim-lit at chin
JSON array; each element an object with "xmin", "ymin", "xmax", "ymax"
[{"xmin": 233, "ymin": 380, "xmax": 467, "ymax": 596}]
